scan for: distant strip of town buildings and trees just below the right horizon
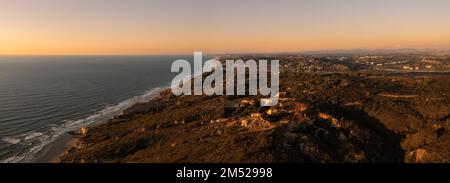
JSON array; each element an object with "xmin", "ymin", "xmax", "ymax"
[{"xmin": 227, "ymin": 54, "xmax": 450, "ymax": 73}]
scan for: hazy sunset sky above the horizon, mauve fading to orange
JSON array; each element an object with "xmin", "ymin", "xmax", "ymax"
[{"xmin": 0, "ymin": 0, "xmax": 450, "ymax": 55}]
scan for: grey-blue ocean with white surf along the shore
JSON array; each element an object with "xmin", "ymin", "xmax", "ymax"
[{"xmin": 0, "ymin": 56, "xmax": 205, "ymax": 162}]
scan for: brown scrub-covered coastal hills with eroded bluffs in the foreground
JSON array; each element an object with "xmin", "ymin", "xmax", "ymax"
[{"xmin": 60, "ymin": 57, "xmax": 450, "ymax": 162}]
